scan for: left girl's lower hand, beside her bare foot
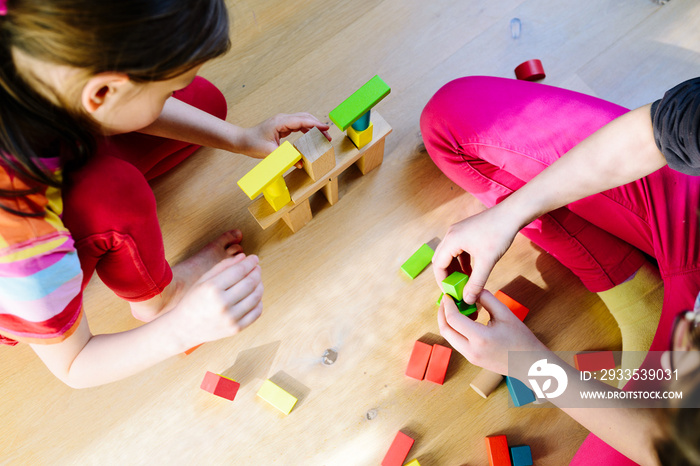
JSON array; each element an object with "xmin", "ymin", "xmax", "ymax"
[{"xmin": 169, "ymin": 253, "xmax": 263, "ymax": 347}]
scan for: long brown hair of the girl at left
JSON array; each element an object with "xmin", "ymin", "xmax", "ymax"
[{"xmin": 0, "ymin": 0, "xmax": 230, "ymax": 215}]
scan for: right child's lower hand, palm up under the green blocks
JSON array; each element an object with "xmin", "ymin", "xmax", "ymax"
[{"xmin": 438, "ymin": 290, "xmax": 547, "ymax": 375}]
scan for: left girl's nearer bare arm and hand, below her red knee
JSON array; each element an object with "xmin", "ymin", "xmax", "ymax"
[{"xmin": 31, "ymin": 254, "xmax": 263, "ymax": 388}]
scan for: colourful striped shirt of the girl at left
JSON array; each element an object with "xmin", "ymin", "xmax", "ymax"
[{"xmin": 0, "ymin": 159, "xmax": 83, "ymax": 345}]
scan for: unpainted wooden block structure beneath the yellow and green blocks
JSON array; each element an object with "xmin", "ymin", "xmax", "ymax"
[{"xmin": 243, "ymin": 112, "xmax": 392, "ymax": 232}]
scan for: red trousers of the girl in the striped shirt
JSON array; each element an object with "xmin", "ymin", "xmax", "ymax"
[{"xmin": 63, "ymin": 77, "xmax": 227, "ymax": 301}]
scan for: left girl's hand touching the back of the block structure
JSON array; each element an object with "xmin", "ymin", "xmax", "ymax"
[{"xmin": 245, "ymin": 113, "xmax": 331, "ymax": 159}]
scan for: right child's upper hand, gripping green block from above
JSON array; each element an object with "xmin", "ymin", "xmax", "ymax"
[{"xmin": 433, "ymin": 205, "xmax": 520, "ymax": 303}]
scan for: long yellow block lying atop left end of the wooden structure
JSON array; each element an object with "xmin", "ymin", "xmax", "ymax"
[{"xmin": 238, "ymin": 141, "xmax": 301, "ymax": 200}]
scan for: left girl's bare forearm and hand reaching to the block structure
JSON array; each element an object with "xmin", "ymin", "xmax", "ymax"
[{"xmin": 140, "ymin": 97, "xmax": 330, "ymax": 158}]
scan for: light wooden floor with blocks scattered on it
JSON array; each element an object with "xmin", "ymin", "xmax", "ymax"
[{"xmin": 0, "ymin": 0, "xmax": 700, "ymax": 466}]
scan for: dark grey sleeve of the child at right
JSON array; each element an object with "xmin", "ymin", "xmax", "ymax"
[{"xmin": 651, "ymin": 78, "xmax": 700, "ymax": 176}]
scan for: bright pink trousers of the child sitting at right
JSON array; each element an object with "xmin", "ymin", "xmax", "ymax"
[{"xmin": 421, "ymin": 76, "xmax": 700, "ymax": 465}]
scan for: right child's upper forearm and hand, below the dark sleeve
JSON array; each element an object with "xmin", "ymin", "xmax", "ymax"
[{"xmin": 433, "ymin": 105, "xmax": 666, "ymax": 303}]
